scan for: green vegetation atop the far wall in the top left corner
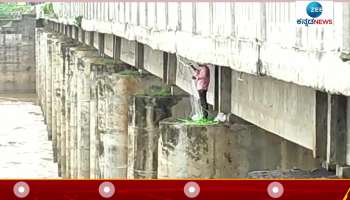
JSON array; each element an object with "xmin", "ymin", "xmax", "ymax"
[{"xmin": 0, "ymin": 3, "xmax": 32, "ymax": 18}]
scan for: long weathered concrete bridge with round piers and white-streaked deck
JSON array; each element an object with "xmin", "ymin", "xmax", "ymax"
[{"xmin": 2, "ymin": 2, "xmax": 350, "ymax": 178}]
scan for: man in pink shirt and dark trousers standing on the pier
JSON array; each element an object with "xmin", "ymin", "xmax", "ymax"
[{"xmin": 190, "ymin": 64, "xmax": 210, "ymax": 119}]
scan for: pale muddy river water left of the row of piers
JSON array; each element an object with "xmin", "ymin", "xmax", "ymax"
[{"xmin": 0, "ymin": 96, "xmax": 57, "ymax": 178}]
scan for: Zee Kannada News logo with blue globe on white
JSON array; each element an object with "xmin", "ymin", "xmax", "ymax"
[{"xmin": 296, "ymin": 1, "xmax": 334, "ymax": 26}]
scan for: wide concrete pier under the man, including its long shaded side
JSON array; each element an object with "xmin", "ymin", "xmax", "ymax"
[{"xmin": 158, "ymin": 120, "xmax": 320, "ymax": 178}]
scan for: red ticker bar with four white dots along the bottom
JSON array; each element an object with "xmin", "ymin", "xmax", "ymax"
[{"xmin": 0, "ymin": 180, "xmax": 350, "ymax": 200}]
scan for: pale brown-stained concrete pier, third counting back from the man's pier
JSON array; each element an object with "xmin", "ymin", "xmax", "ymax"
[{"xmin": 100, "ymin": 72, "xmax": 161, "ymax": 178}]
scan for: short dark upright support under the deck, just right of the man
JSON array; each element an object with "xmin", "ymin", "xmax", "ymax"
[{"xmin": 218, "ymin": 66, "xmax": 234, "ymax": 113}]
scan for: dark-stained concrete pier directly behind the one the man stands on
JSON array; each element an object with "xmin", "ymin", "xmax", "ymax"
[{"xmin": 128, "ymin": 95, "xmax": 191, "ymax": 179}]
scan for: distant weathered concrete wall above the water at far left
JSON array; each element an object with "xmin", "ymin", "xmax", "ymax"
[{"xmin": 0, "ymin": 15, "xmax": 36, "ymax": 93}]
